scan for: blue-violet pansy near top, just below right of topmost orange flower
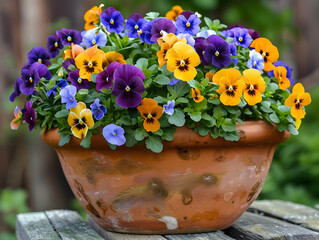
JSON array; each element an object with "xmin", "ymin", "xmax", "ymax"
[{"xmin": 176, "ymin": 13, "xmax": 202, "ymax": 35}]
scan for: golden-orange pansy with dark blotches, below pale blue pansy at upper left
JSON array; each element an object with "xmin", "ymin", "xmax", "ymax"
[{"xmin": 74, "ymin": 46, "xmax": 103, "ymax": 81}]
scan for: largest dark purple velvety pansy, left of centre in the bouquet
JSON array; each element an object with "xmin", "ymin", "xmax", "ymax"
[{"xmin": 112, "ymin": 64, "xmax": 145, "ymax": 108}]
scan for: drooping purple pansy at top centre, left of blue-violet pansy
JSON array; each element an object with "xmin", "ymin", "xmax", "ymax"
[{"xmin": 151, "ymin": 18, "xmax": 176, "ymax": 42}]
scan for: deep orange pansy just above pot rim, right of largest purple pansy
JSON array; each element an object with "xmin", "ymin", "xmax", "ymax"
[{"xmin": 137, "ymin": 98, "xmax": 163, "ymax": 132}]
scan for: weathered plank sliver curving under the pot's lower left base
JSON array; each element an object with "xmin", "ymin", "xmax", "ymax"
[{"xmin": 87, "ymin": 216, "xmax": 167, "ymax": 240}]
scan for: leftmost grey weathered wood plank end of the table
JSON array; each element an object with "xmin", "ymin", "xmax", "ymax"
[{"xmin": 16, "ymin": 212, "xmax": 61, "ymax": 240}]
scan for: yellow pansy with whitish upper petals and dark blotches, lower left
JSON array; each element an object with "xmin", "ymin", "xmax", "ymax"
[{"xmin": 68, "ymin": 102, "xmax": 94, "ymax": 139}]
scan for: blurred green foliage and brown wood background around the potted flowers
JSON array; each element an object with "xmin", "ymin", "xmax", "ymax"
[{"xmin": 0, "ymin": 0, "xmax": 319, "ymax": 237}]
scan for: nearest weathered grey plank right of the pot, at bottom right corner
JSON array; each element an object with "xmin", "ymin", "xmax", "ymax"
[{"xmin": 224, "ymin": 212, "xmax": 319, "ymax": 240}]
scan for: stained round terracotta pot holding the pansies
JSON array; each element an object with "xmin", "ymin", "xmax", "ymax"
[{"xmin": 42, "ymin": 121, "xmax": 289, "ymax": 234}]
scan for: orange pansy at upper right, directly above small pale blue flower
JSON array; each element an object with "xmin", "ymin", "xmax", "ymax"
[{"xmin": 250, "ymin": 38, "xmax": 279, "ymax": 71}]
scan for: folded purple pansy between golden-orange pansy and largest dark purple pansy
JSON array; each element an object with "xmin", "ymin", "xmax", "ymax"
[{"xmin": 96, "ymin": 62, "xmax": 122, "ymax": 91}]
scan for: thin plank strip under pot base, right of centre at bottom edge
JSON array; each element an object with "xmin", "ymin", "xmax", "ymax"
[{"xmin": 165, "ymin": 231, "xmax": 234, "ymax": 240}]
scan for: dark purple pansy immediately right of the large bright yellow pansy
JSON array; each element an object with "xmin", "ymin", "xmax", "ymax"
[{"xmin": 204, "ymin": 35, "xmax": 231, "ymax": 68}]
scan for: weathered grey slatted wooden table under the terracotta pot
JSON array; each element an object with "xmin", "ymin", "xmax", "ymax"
[{"xmin": 16, "ymin": 200, "xmax": 319, "ymax": 240}]
